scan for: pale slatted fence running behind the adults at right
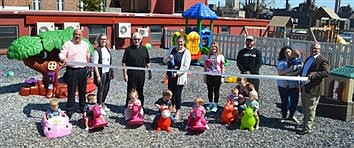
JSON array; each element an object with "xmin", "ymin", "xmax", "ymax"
[{"xmin": 163, "ymin": 30, "xmax": 354, "ymax": 69}]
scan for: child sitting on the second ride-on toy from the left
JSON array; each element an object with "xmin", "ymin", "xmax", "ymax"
[{"xmin": 83, "ymin": 94, "xmax": 103, "ymax": 131}]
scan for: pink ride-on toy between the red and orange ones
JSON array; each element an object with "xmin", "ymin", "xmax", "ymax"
[{"xmin": 187, "ymin": 108, "xmax": 208, "ymax": 132}]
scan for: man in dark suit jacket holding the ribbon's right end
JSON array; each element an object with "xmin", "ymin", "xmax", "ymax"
[{"xmin": 298, "ymin": 42, "xmax": 329, "ymax": 135}]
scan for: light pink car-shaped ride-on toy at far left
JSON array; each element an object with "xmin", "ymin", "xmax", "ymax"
[{"xmin": 42, "ymin": 113, "xmax": 72, "ymax": 138}]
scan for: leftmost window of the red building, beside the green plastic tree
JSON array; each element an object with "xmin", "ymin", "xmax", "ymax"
[{"xmin": 0, "ymin": 26, "xmax": 18, "ymax": 49}]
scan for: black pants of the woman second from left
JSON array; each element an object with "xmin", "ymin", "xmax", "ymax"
[{"xmin": 97, "ymin": 72, "xmax": 111, "ymax": 105}]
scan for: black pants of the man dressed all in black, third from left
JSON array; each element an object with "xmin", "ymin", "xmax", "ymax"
[{"xmin": 125, "ymin": 70, "xmax": 145, "ymax": 108}]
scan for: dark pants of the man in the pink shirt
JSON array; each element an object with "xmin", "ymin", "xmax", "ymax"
[{"xmin": 66, "ymin": 67, "xmax": 87, "ymax": 113}]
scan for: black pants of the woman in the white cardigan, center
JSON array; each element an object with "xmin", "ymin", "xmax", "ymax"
[{"xmin": 168, "ymin": 77, "xmax": 184, "ymax": 109}]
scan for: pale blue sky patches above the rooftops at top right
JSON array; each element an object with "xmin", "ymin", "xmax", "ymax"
[{"xmin": 208, "ymin": 0, "xmax": 354, "ymax": 10}]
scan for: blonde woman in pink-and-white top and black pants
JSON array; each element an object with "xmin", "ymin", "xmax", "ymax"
[{"xmin": 204, "ymin": 42, "xmax": 224, "ymax": 112}]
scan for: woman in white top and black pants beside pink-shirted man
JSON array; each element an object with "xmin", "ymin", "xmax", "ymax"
[{"xmin": 92, "ymin": 34, "xmax": 113, "ymax": 114}]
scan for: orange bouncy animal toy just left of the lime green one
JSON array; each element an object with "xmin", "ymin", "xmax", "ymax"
[{"xmin": 221, "ymin": 100, "xmax": 236, "ymax": 125}]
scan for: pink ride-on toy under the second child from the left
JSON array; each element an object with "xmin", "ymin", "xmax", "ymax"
[{"xmin": 88, "ymin": 105, "xmax": 108, "ymax": 129}]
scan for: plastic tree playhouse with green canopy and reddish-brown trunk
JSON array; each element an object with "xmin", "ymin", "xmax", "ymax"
[{"xmin": 7, "ymin": 27, "xmax": 96, "ymax": 98}]
